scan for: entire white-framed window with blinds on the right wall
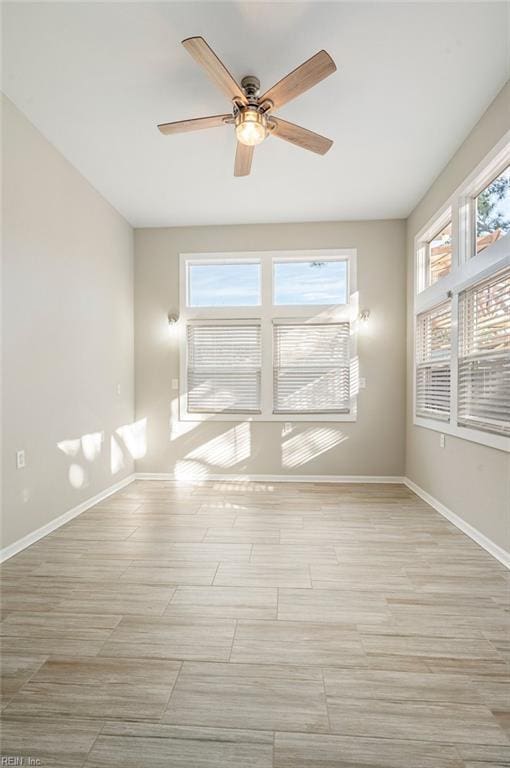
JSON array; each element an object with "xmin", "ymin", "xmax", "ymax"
[{"xmin": 414, "ymin": 139, "xmax": 510, "ymax": 450}]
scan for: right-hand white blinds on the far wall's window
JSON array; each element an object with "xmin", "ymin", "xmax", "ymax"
[{"xmin": 273, "ymin": 323, "xmax": 350, "ymax": 413}]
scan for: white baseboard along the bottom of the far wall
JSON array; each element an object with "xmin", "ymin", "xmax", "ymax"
[{"xmin": 135, "ymin": 472, "xmax": 404, "ymax": 485}]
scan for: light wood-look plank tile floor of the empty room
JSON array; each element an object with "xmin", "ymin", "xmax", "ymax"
[{"xmin": 0, "ymin": 481, "xmax": 510, "ymax": 768}]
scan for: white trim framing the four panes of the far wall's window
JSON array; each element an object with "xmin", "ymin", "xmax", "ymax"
[{"xmin": 179, "ymin": 248, "xmax": 360, "ymax": 422}]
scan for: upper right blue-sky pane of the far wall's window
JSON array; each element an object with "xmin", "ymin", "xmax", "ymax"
[{"xmin": 274, "ymin": 261, "xmax": 347, "ymax": 306}]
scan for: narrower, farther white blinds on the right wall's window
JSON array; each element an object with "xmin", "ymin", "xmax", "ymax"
[{"xmin": 416, "ymin": 301, "xmax": 452, "ymax": 421}]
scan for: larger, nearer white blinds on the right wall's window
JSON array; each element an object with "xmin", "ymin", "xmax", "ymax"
[{"xmin": 458, "ymin": 269, "xmax": 510, "ymax": 435}]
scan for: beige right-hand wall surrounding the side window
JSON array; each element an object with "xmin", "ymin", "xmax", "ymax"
[{"xmin": 406, "ymin": 84, "xmax": 510, "ymax": 550}]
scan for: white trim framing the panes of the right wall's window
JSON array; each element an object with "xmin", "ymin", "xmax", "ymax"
[{"xmin": 413, "ymin": 131, "xmax": 510, "ymax": 452}]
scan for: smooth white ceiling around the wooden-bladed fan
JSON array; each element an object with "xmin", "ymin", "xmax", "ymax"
[{"xmin": 3, "ymin": 2, "xmax": 509, "ymax": 226}]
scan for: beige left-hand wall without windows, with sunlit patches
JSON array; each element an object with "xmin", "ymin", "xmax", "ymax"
[{"xmin": 2, "ymin": 99, "xmax": 133, "ymax": 546}]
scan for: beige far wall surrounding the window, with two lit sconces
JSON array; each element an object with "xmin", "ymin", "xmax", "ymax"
[{"xmin": 135, "ymin": 221, "xmax": 405, "ymax": 476}]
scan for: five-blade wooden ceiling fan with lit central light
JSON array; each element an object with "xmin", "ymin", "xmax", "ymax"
[{"xmin": 158, "ymin": 37, "xmax": 336, "ymax": 176}]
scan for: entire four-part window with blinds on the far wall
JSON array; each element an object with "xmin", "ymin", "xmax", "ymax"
[{"xmin": 180, "ymin": 250, "xmax": 358, "ymax": 421}]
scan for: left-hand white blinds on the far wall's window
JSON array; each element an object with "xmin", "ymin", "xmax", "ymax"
[{"xmin": 187, "ymin": 323, "xmax": 261, "ymax": 413}]
